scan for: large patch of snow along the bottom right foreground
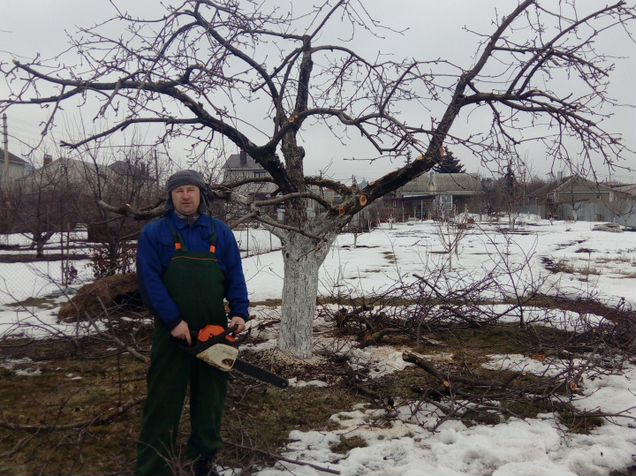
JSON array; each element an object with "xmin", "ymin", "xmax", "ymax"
[{"xmin": 258, "ymin": 398, "xmax": 636, "ymax": 476}]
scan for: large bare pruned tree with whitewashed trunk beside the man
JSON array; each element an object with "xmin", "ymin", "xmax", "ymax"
[{"xmin": 0, "ymin": 0, "xmax": 635, "ymax": 357}]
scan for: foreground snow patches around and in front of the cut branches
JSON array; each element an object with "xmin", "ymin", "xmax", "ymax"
[{"xmin": 240, "ymin": 306, "xmax": 636, "ymax": 476}]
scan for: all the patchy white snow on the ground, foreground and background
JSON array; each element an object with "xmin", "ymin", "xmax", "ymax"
[{"xmin": 0, "ymin": 219, "xmax": 636, "ymax": 476}]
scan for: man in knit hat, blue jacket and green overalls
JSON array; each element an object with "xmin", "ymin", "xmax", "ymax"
[{"xmin": 136, "ymin": 170, "xmax": 249, "ymax": 476}]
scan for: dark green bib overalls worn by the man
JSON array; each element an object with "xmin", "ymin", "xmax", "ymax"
[{"xmin": 136, "ymin": 221, "xmax": 227, "ymax": 476}]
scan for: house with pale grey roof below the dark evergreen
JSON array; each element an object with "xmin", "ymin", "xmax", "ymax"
[{"xmin": 394, "ymin": 171, "xmax": 482, "ymax": 219}]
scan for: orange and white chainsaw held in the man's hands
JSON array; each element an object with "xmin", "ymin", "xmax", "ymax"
[{"xmin": 172, "ymin": 324, "xmax": 289, "ymax": 388}]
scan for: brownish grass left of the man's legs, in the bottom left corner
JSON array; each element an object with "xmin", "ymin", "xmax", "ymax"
[{"xmin": 0, "ymin": 341, "xmax": 145, "ymax": 476}]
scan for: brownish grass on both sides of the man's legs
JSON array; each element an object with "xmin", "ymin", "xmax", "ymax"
[{"xmin": 0, "ymin": 335, "xmax": 361, "ymax": 476}]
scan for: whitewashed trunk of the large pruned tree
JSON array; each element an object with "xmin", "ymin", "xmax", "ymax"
[{"xmin": 278, "ymin": 233, "xmax": 335, "ymax": 359}]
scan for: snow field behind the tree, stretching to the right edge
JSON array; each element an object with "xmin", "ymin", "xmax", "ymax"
[{"xmin": 238, "ymin": 221, "xmax": 636, "ymax": 305}]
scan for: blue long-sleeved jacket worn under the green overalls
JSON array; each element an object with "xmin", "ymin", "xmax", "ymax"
[{"xmin": 137, "ymin": 211, "xmax": 249, "ymax": 330}]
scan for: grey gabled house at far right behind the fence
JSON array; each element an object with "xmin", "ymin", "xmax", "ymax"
[{"xmin": 531, "ymin": 175, "xmax": 634, "ymax": 222}]
